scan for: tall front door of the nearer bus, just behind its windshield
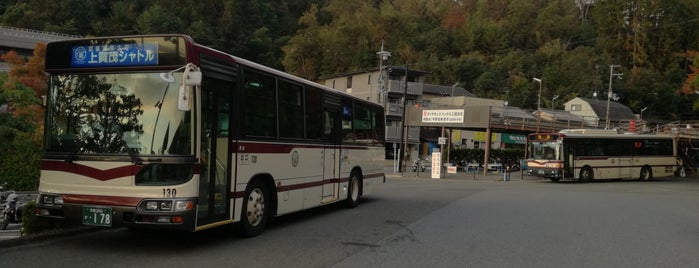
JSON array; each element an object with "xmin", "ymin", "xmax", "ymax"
[{"xmin": 197, "ymin": 76, "xmax": 233, "ymax": 226}]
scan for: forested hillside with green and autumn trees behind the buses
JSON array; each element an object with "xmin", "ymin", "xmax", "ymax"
[{"xmin": 0, "ymin": 0, "xmax": 699, "ymax": 120}]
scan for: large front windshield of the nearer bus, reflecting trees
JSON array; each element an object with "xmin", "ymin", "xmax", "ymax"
[{"xmin": 45, "ymin": 72, "xmax": 194, "ymax": 157}]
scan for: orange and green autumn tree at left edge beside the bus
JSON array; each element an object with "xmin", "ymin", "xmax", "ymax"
[{"xmin": 0, "ymin": 44, "xmax": 46, "ymax": 190}]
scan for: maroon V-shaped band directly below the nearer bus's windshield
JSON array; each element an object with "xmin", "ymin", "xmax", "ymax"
[{"xmin": 41, "ymin": 161, "xmax": 141, "ymax": 181}]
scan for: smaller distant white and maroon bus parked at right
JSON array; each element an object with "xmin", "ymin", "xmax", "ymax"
[{"xmin": 527, "ymin": 129, "xmax": 677, "ymax": 182}]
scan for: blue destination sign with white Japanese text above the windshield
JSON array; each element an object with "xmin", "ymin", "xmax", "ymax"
[{"xmin": 70, "ymin": 43, "xmax": 158, "ymax": 67}]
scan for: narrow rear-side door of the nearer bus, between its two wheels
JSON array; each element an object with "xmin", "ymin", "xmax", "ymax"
[{"xmin": 321, "ymin": 108, "xmax": 341, "ymax": 203}]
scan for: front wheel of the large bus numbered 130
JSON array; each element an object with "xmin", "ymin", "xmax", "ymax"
[{"xmin": 239, "ymin": 180, "xmax": 271, "ymax": 237}]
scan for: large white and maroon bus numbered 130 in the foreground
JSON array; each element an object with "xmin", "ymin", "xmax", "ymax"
[{"xmin": 37, "ymin": 35, "xmax": 385, "ymax": 236}]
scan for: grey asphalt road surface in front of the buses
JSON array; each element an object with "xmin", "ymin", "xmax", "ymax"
[{"xmin": 0, "ymin": 174, "xmax": 699, "ymax": 267}]
